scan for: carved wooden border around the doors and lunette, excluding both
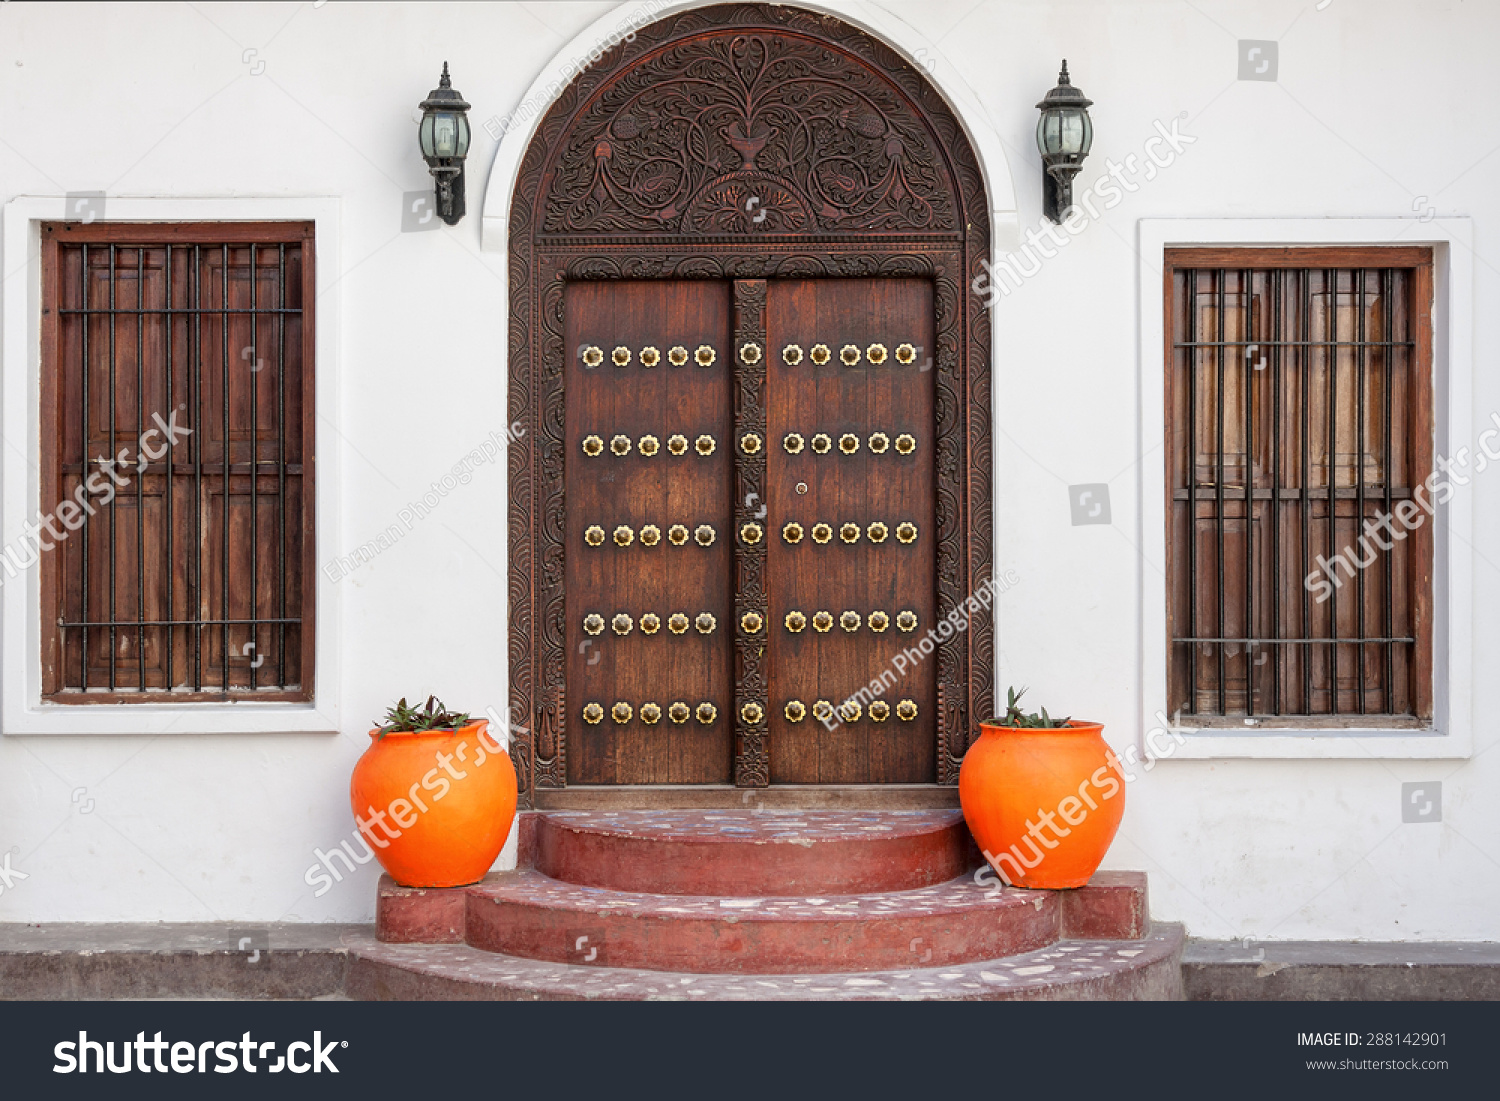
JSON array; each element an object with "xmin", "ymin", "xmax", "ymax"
[{"xmin": 509, "ymin": 5, "xmax": 995, "ymax": 807}]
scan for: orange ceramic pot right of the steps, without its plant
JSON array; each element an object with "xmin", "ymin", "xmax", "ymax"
[{"xmin": 959, "ymin": 722, "xmax": 1125, "ymax": 890}]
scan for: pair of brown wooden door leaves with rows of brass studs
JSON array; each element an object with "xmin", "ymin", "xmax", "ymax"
[{"xmin": 563, "ymin": 279, "xmax": 938, "ymax": 785}]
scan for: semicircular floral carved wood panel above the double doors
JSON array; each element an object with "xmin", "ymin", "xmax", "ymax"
[{"xmin": 543, "ymin": 32, "xmax": 957, "ymax": 236}]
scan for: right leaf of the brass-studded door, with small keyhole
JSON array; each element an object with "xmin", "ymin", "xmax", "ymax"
[{"xmin": 767, "ymin": 279, "xmax": 938, "ymax": 783}]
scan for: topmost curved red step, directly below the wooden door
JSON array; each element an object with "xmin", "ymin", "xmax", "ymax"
[{"xmin": 533, "ymin": 810, "xmax": 978, "ymax": 897}]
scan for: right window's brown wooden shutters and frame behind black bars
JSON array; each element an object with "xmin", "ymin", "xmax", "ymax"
[{"xmin": 1169, "ymin": 269, "xmax": 1431, "ymax": 726}]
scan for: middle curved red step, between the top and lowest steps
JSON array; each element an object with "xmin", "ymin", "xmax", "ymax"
[{"xmin": 465, "ymin": 872, "xmax": 1061, "ymax": 974}]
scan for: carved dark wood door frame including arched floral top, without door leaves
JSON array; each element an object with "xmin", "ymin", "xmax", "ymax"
[{"xmin": 509, "ymin": 5, "xmax": 995, "ymax": 807}]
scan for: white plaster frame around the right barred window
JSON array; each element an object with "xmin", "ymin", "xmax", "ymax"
[{"xmin": 1139, "ymin": 218, "xmax": 1470, "ymax": 761}]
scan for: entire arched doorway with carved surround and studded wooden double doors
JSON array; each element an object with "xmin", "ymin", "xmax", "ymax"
[{"xmin": 509, "ymin": 5, "xmax": 993, "ymax": 801}]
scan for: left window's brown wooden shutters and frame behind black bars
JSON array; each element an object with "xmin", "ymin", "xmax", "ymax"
[{"xmin": 44, "ymin": 231, "xmax": 311, "ymax": 701}]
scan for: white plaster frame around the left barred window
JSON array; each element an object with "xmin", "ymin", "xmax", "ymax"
[{"xmin": 0, "ymin": 195, "xmax": 341, "ymax": 735}]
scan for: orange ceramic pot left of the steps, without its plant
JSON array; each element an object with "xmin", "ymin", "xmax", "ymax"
[{"xmin": 350, "ymin": 719, "xmax": 516, "ymax": 887}]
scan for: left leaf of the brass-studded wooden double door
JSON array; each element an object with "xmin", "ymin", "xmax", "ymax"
[{"xmin": 563, "ymin": 281, "xmax": 737, "ymax": 785}]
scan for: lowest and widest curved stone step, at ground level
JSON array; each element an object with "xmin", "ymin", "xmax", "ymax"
[{"xmin": 344, "ymin": 924, "xmax": 1184, "ymax": 1002}]
